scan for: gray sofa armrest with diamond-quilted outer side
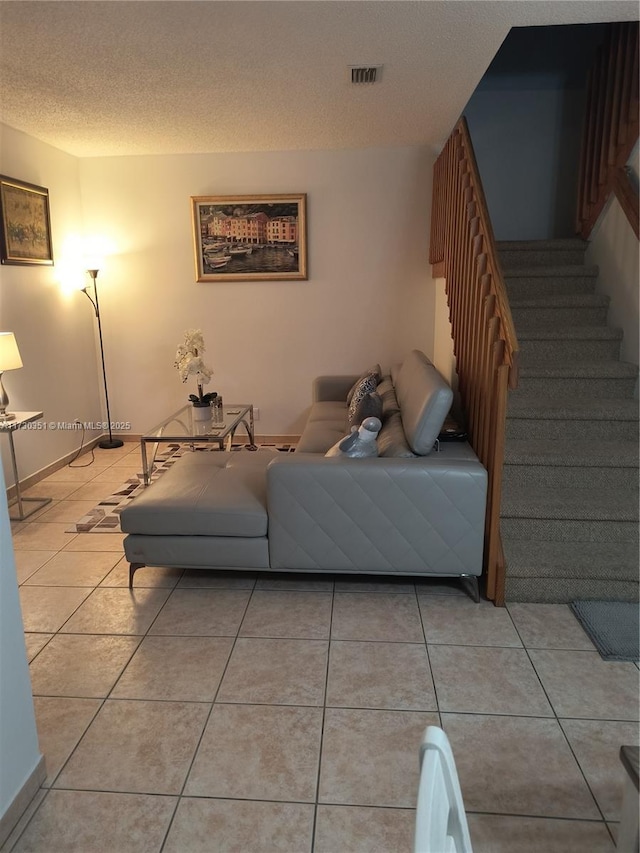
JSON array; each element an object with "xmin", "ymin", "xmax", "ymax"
[{"xmin": 267, "ymin": 452, "xmax": 487, "ymax": 575}]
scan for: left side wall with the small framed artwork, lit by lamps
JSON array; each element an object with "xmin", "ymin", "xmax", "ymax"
[{"xmin": 0, "ymin": 125, "xmax": 102, "ymax": 485}]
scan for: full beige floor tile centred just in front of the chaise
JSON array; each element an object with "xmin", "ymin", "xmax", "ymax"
[{"xmin": 150, "ymin": 589, "xmax": 251, "ymax": 637}]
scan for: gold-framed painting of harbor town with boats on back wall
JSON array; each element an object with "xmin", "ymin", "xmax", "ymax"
[{"xmin": 191, "ymin": 193, "xmax": 307, "ymax": 281}]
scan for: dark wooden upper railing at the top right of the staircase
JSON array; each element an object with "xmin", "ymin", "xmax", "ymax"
[{"xmin": 576, "ymin": 21, "xmax": 639, "ymax": 240}]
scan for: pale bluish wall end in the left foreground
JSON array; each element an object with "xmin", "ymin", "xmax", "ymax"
[{"xmin": 0, "ymin": 467, "xmax": 41, "ymax": 846}]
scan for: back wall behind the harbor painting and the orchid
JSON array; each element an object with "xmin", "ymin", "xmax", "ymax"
[{"xmin": 79, "ymin": 147, "xmax": 435, "ymax": 435}]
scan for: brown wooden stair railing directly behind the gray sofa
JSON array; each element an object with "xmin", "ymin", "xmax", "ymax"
[{"xmin": 429, "ymin": 118, "xmax": 518, "ymax": 605}]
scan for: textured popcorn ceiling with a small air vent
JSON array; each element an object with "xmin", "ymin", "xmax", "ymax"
[{"xmin": 0, "ymin": 0, "xmax": 638, "ymax": 157}]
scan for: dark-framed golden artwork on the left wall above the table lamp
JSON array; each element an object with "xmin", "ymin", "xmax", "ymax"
[{"xmin": 0, "ymin": 175, "xmax": 53, "ymax": 264}]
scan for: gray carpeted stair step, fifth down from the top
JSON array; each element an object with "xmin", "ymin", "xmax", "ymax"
[{"xmin": 509, "ymin": 360, "xmax": 638, "ymax": 405}]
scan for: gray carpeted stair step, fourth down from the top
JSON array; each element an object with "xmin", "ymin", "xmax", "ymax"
[{"xmin": 518, "ymin": 325, "xmax": 622, "ymax": 364}]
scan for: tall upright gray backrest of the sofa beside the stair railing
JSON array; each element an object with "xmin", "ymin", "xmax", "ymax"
[{"xmin": 394, "ymin": 350, "xmax": 453, "ymax": 456}]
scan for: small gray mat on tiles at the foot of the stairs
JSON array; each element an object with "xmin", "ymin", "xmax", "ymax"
[{"xmin": 570, "ymin": 601, "xmax": 640, "ymax": 661}]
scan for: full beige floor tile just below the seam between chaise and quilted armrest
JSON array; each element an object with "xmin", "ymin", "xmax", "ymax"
[{"xmin": 240, "ymin": 590, "xmax": 332, "ymax": 640}]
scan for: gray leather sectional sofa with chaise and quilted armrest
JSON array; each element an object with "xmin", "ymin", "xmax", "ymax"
[{"xmin": 121, "ymin": 350, "xmax": 487, "ymax": 600}]
